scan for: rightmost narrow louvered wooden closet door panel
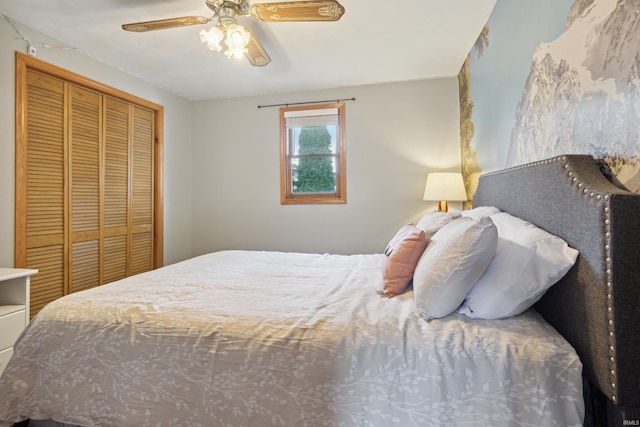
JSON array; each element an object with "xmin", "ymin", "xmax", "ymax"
[{"xmin": 131, "ymin": 107, "xmax": 154, "ymax": 274}]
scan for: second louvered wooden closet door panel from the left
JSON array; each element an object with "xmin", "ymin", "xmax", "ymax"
[{"xmin": 69, "ymin": 86, "xmax": 101, "ymax": 292}]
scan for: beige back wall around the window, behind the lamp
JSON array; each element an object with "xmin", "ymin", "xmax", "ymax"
[{"xmin": 192, "ymin": 77, "xmax": 460, "ymax": 255}]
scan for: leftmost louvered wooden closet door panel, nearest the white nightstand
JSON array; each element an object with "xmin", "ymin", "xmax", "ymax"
[{"xmin": 25, "ymin": 72, "xmax": 65, "ymax": 313}]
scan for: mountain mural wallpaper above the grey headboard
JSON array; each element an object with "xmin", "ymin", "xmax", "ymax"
[{"xmin": 458, "ymin": 0, "xmax": 640, "ymax": 196}]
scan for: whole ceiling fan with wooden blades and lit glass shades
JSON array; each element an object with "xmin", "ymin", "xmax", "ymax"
[{"xmin": 122, "ymin": 0, "xmax": 344, "ymax": 67}]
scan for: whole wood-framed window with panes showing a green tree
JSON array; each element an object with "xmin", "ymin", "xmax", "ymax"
[{"xmin": 280, "ymin": 103, "xmax": 347, "ymax": 205}]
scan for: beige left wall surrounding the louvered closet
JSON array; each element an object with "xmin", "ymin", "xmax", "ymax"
[{"xmin": 0, "ymin": 17, "xmax": 192, "ymax": 267}]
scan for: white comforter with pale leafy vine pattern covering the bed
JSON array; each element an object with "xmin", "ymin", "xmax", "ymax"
[{"xmin": 0, "ymin": 251, "xmax": 584, "ymax": 427}]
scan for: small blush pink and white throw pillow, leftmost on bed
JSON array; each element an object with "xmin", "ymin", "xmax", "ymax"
[{"xmin": 383, "ymin": 224, "xmax": 427, "ymax": 298}]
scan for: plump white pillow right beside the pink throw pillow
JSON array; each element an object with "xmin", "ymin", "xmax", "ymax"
[{"xmin": 413, "ymin": 217, "xmax": 498, "ymax": 320}]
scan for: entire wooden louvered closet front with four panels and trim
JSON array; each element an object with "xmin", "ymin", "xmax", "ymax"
[{"xmin": 15, "ymin": 55, "xmax": 163, "ymax": 317}]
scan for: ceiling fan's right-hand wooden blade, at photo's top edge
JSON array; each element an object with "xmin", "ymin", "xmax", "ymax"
[{"xmin": 248, "ymin": 0, "xmax": 344, "ymax": 22}]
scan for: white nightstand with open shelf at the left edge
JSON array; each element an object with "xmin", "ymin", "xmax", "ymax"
[{"xmin": 0, "ymin": 268, "xmax": 38, "ymax": 374}]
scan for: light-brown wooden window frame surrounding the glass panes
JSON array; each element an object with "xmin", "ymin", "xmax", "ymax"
[{"xmin": 280, "ymin": 102, "xmax": 347, "ymax": 205}]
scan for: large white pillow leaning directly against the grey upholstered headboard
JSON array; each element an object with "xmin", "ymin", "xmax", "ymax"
[{"xmin": 460, "ymin": 212, "xmax": 578, "ymax": 319}]
